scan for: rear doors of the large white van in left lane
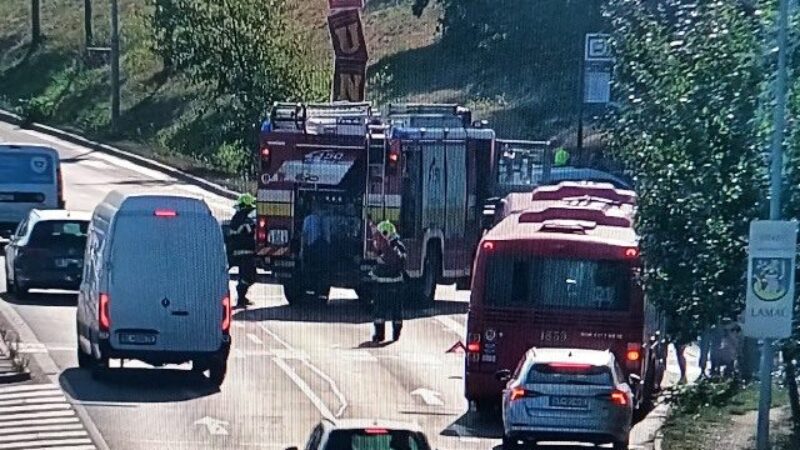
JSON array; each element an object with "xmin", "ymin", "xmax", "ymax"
[{"xmin": 109, "ymin": 210, "xmax": 228, "ymax": 352}]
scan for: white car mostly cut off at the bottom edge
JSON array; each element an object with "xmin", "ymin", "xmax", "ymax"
[{"xmin": 286, "ymin": 419, "xmax": 431, "ymax": 450}]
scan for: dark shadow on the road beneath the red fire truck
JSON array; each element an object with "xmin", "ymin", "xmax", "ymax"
[{"xmin": 234, "ymin": 299, "xmax": 469, "ymax": 324}]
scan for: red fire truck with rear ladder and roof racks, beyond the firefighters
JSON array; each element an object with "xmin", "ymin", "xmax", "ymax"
[{"xmin": 256, "ymin": 103, "xmax": 494, "ymax": 304}]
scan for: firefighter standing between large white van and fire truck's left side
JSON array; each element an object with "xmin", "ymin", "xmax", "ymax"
[{"xmin": 230, "ymin": 194, "xmax": 256, "ymax": 308}]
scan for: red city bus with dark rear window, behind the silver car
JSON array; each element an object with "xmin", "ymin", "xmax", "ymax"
[{"xmin": 465, "ymin": 201, "xmax": 666, "ymax": 410}]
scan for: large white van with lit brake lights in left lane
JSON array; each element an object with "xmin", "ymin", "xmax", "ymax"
[{"xmin": 77, "ymin": 192, "xmax": 231, "ymax": 385}]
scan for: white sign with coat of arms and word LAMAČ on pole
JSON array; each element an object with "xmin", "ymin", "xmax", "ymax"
[{"xmin": 744, "ymin": 220, "xmax": 797, "ymax": 339}]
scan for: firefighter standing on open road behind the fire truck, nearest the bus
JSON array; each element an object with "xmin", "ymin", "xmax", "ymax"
[{"xmin": 370, "ymin": 220, "xmax": 406, "ymax": 343}]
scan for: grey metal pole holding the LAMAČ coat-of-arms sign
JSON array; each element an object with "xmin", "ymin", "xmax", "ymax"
[{"xmin": 756, "ymin": 0, "xmax": 789, "ymax": 450}]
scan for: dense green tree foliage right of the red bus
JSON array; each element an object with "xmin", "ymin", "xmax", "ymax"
[{"xmin": 608, "ymin": 0, "xmax": 766, "ymax": 340}]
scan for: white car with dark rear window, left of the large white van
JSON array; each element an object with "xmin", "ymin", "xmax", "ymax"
[{"xmin": 5, "ymin": 209, "xmax": 91, "ymax": 299}]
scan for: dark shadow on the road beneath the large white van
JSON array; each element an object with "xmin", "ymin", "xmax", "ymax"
[{"xmin": 59, "ymin": 367, "xmax": 219, "ymax": 405}]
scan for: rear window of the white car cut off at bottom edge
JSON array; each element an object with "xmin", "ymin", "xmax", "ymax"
[{"xmin": 325, "ymin": 428, "xmax": 430, "ymax": 450}]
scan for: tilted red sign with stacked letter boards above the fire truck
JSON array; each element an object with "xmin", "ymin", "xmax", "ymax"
[{"xmin": 328, "ymin": 0, "xmax": 369, "ymax": 102}]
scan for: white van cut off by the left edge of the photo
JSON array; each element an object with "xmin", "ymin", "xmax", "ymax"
[{"xmin": 0, "ymin": 143, "xmax": 64, "ymax": 245}]
